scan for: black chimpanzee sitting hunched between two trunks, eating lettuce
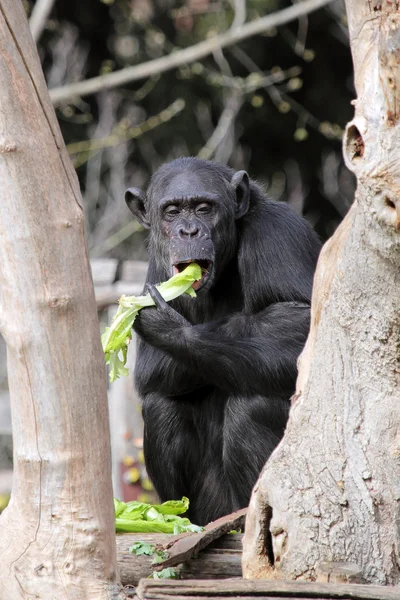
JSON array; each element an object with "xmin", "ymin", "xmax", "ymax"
[{"xmin": 125, "ymin": 158, "xmax": 320, "ymax": 524}]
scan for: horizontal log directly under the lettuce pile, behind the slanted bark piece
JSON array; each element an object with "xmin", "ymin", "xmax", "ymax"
[{"xmin": 116, "ymin": 533, "xmax": 243, "ymax": 585}]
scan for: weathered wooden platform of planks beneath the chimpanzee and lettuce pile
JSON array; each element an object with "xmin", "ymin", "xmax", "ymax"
[{"xmin": 117, "ymin": 509, "xmax": 400, "ymax": 600}]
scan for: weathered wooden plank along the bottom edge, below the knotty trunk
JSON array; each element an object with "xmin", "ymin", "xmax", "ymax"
[{"xmin": 136, "ymin": 579, "xmax": 400, "ymax": 600}]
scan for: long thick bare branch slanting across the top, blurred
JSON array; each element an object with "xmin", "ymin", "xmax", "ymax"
[{"xmin": 50, "ymin": 0, "xmax": 332, "ymax": 104}]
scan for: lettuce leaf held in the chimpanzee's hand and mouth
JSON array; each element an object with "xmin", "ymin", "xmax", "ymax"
[{"xmin": 101, "ymin": 263, "xmax": 202, "ymax": 382}]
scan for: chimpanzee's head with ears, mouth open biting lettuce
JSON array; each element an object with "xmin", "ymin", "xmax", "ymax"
[{"xmin": 126, "ymin": 161, "xmax": 248, "ymax": 291}]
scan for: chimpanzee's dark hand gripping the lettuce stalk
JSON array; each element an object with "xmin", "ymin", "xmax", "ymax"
[{"xmin": 133, "ymin": 283, "xmax": 191, "ymax": 347}]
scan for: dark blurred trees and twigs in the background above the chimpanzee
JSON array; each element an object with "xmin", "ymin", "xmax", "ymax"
[{"xmin": 25, "ymin": 0, "xmax": 354, "ymax": 260}]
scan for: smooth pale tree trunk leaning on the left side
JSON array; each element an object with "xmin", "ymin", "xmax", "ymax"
[{"xmin": 0, "ymin": 0, "xmax": 119, "ymax": 600}]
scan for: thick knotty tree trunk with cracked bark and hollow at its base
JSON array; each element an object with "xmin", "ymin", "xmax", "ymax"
[{"xmin": 243, "ymin": 0, "xmax": 400, "ymax": 585}]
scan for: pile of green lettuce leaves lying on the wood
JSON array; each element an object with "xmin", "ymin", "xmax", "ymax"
[{"xmin": 114, "ymin": 497, "xmax": 202, "ymax": 534}]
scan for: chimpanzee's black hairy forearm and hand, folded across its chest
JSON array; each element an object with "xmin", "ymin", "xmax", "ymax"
[{"xmin": 134, "ymin": 289, "xmax": 310, "ymax": 395}]
